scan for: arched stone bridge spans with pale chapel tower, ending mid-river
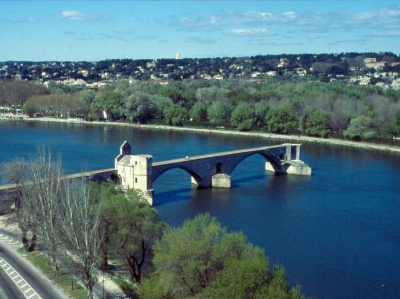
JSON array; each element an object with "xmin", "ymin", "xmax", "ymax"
[{"xmin": 115, "ymin": 141, "xmax": 311, "ymax": 203}]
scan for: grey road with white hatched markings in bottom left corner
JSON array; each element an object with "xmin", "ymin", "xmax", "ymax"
[{"xmin": 0, "ymin": 231, "xmax": 69, "ymax": 299}]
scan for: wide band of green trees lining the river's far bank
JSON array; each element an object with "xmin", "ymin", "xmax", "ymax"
[{"xmin": 0, "ymin": 79, "xmax": 400, "ymax": 140}]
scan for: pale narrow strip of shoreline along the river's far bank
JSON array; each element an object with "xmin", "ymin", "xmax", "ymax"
[{"xmin": 5, "ymin": 117, "xmax": 400, "ymax": 154}]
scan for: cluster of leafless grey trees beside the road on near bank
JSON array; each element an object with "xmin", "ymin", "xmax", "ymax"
[{"xmin": 1, "ymin": 148, "xmax": 104, "ymax": 298}]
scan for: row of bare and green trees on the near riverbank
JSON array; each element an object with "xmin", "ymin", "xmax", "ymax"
[{"xmin": 1, "ymin": 148, "xmax": 305, "ymax": 299}]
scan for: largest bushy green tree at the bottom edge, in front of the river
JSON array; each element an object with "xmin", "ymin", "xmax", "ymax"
[{"xmin": 141, "ymin": 214, "xmax": 302, "ymax": 299}]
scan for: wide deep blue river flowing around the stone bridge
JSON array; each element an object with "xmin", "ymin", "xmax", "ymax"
[{"xmin": 0, "ymin": 121, "xmax": 400, "ymax": 299}]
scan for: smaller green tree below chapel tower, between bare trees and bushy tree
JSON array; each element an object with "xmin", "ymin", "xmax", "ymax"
[{"xmin": 101, "ymin": 186, "xmax": 165, "ymax": 283}]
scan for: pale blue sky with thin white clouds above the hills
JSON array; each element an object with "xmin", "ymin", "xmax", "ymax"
[{"xmin": 0, "ymin": 0, "xmax": 400, "ymax": 61}]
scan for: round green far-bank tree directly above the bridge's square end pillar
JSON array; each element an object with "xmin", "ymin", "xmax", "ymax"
[{"xmin": 265, "ymin": 106, "xmax": 297, "ymax": 134}]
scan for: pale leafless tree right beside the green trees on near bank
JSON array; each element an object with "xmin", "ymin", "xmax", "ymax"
[{"xmin": 57, "ymin": 181, "xmax": 104, "ymax": 299}]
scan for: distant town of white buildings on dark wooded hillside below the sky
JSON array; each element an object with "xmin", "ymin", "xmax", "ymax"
[{"xmin": 0, "ymin": 52, "xmax": 400, "ymax": 89}]
